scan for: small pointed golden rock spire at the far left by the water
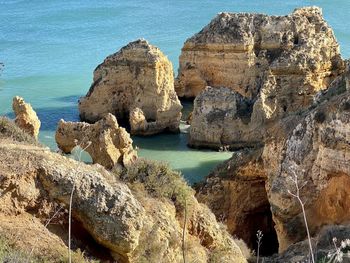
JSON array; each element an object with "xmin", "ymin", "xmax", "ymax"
[{"xmin": 12, "ymin": 96, "xmax": 41, "ymax": 139}]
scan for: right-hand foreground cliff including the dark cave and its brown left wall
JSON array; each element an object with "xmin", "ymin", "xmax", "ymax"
[{"xmin": 197, "ymin": 69, "xmax": 350, "ymax": 255}]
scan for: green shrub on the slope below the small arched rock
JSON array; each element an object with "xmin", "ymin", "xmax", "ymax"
[{"xmin": 117, "ymin": 158, "xmax": 194, "ymax": 208}]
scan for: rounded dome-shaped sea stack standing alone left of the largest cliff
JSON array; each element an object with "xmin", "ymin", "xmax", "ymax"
[{"xmin": 79, "ymin": 40, "xmax": 182, "ymax": 135}]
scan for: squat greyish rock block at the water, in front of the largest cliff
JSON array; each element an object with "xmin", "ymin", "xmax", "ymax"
[{"xmin": 188, "ymin": 87, "xmax": 265, "ymax": 149}]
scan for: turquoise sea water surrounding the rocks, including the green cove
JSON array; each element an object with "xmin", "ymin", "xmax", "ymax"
[{"xmin": 0, "ymin": 0, "xmax": 350, "ymax": 183}]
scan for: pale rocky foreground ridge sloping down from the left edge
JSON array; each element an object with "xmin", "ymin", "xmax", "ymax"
[{"xmin": 0, "ymin": 130, "xmax": 247, "ymax": 263}]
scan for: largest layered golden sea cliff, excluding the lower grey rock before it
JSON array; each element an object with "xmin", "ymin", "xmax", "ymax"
[{"xmin": 176, "ymin": 7, "xmax": 343, "ymax": 100}]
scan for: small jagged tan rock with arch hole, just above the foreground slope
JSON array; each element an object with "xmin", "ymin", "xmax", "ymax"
[{"xmin": 55, "ymin": 113, "xmax": 137, "ymax": 169}]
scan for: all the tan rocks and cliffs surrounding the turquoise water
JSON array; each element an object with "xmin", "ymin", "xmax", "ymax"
[{"xmin": 0, "ymin": 4, "xmax": 350, "ymax": 263}]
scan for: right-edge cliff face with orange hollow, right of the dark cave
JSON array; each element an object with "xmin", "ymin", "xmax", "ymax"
[{"xmin": 263, "ymin": 82, "xmax": 350, "ymax": 251}]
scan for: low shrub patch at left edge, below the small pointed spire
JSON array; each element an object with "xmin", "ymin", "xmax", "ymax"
[{"xmin": 0, "ymin": 116, "xmax": 39, "ymax": 145}]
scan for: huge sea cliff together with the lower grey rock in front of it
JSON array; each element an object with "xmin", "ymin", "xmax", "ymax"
[{"xmin": 186, "ymin": 7, "xmax": 345, "ymax": 148}]
